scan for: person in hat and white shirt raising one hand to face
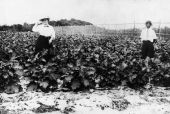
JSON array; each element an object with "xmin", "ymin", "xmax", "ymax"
[{"xmin": 32, "ymin": 17, "xmax": 55, "ymax": 60}]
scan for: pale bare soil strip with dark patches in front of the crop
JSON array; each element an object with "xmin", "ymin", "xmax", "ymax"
[{"xmin": 0, "ymin": 87, "xmax": 170, "ymax": 114}]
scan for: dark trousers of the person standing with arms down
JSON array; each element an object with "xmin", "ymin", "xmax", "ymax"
[{"xmin": 142, "ymin": 40, "xmax": 155, "ymax": 59}]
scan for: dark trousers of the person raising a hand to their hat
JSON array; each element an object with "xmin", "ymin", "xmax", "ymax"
[{"xmin": 34, "ymin": 35, "xmax": 53, "ymax": 61}]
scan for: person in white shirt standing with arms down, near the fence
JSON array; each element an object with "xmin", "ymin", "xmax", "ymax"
[{"xmin": 140, "ymin": 21, "xmax": 157, "ymax": 59}]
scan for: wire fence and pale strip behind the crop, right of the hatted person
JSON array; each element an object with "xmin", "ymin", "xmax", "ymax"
[{"xmin": 55, "ymin": 22, "xmax": 170, "ymax": 38}]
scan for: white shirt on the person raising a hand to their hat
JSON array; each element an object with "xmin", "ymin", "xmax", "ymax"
[{"xmin": 32, "ymin": 24, "xmax": 55, "ymax": 39}]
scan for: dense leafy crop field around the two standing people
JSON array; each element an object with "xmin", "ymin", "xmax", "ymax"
[{"xmin": 0, "ymin": 32, "xmax": 170, "ymax": 113}]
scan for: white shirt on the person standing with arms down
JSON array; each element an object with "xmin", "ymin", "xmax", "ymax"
[{"xmin": 140, "ymin": 28, "xmax": 157, "ymax": 42}]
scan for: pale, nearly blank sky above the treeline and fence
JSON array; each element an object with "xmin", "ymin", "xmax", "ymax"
[{"xmin": 0, "ymin": 0, "xmax": 170, "ymax": 25}]
